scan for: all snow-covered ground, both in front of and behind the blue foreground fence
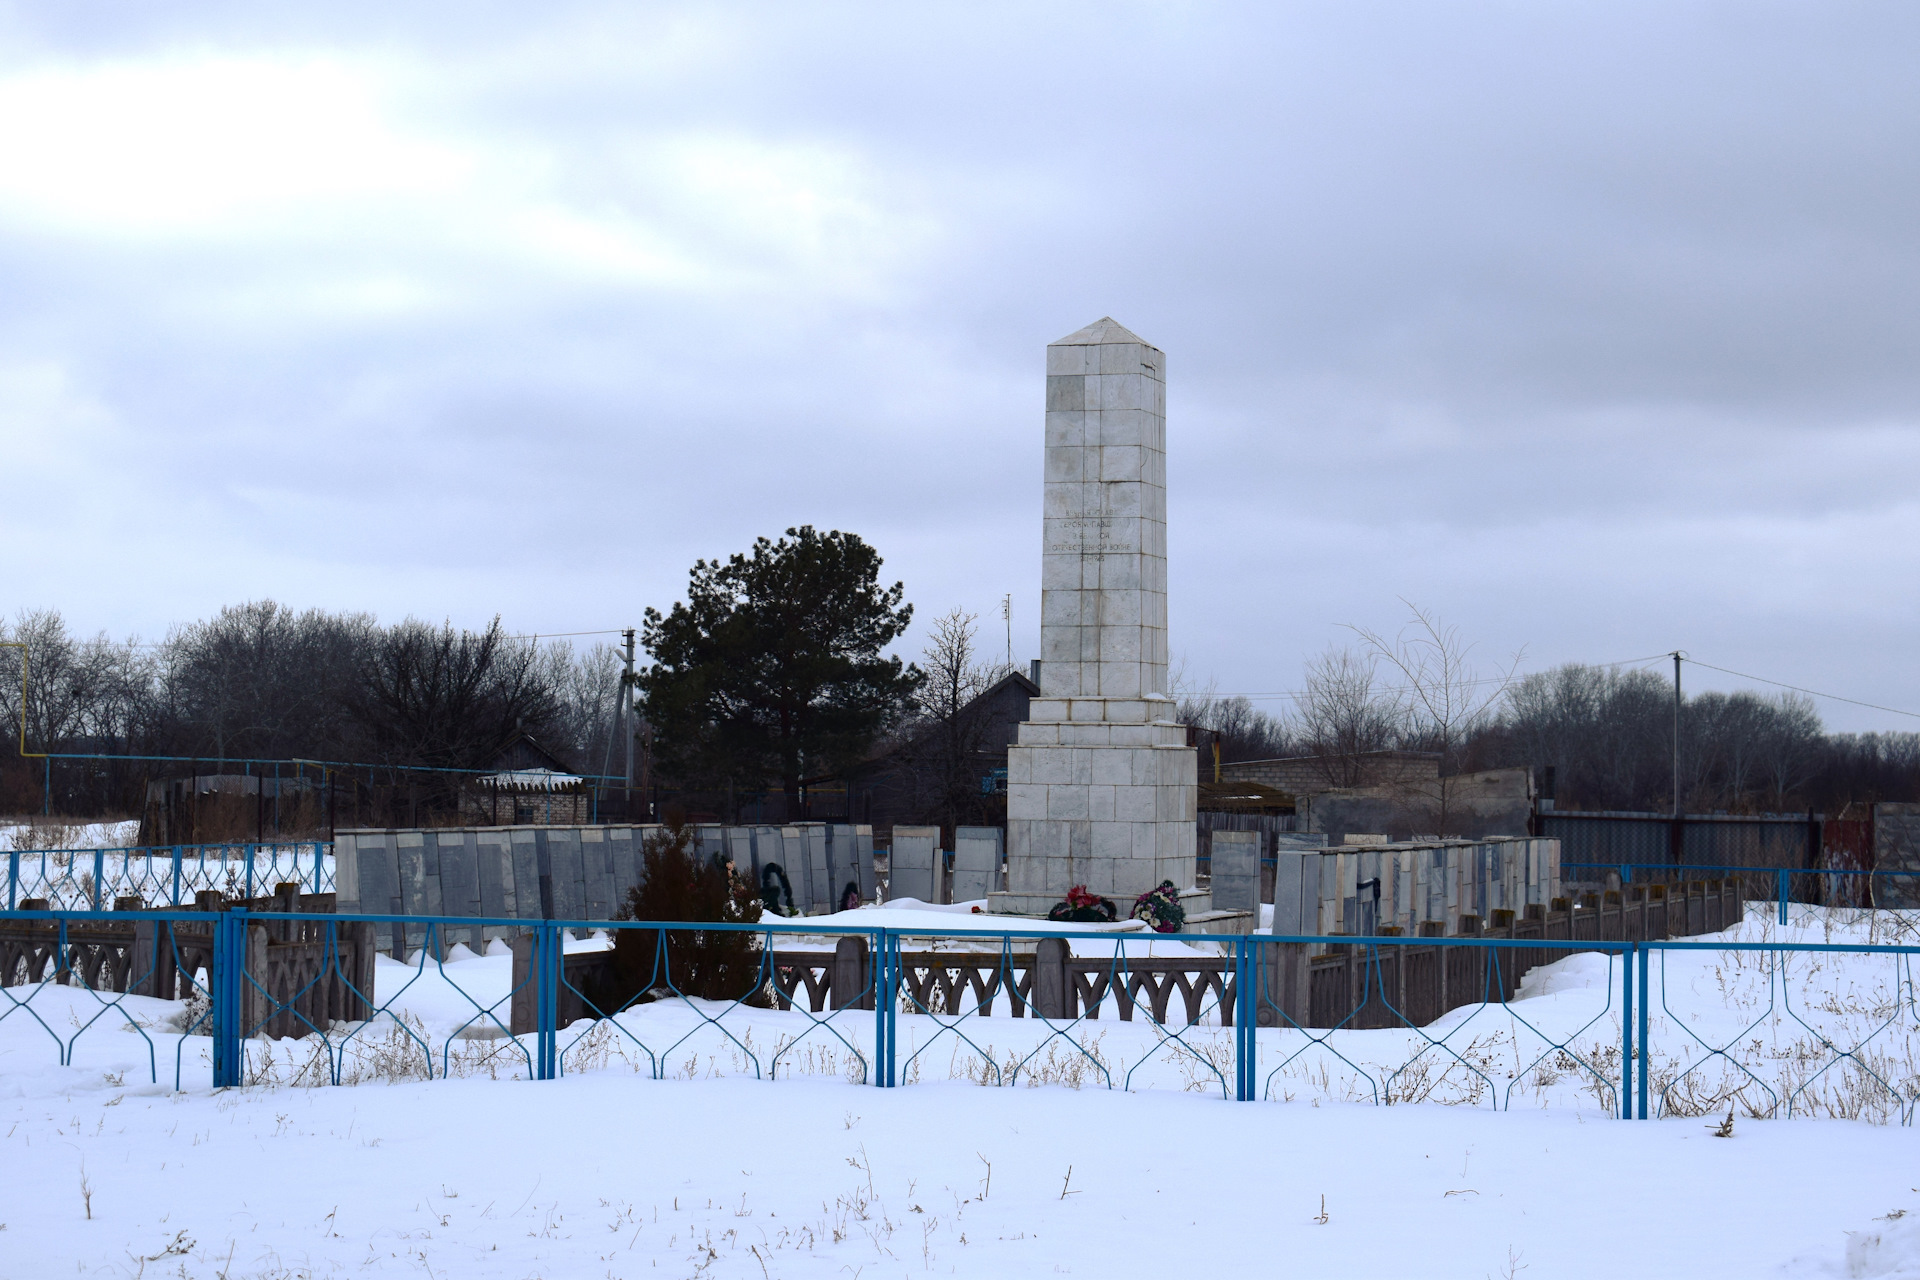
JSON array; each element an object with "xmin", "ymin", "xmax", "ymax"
[{"xmin": 0, "ymin": 904, "xmax": 1920, "ymax": 1280}]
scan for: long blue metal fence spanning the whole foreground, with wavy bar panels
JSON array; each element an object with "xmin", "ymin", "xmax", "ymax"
[{"xmin": 0, "ymin": 910, "xmax": 1920, "ymax": 1123}]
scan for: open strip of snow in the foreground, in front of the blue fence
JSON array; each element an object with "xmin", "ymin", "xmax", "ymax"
[{"xmin": 0, "ymin": 1073, "xmax": 1920, "ymax": 1280}]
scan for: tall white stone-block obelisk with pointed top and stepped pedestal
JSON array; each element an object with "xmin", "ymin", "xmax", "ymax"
[{"xmin": 993, "ymin": 319, "xmax": 1206, "ymax": 915}]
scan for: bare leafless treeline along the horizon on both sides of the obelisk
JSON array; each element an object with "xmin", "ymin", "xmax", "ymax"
[{"xmin": 0, "ymin": 601, "xmax": 1920, "ymax": 814}]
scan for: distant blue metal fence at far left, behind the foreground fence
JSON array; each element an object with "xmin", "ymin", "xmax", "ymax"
[{"xmin": 6, "ymin": 841, "xmax": 334, "ymax": 912}]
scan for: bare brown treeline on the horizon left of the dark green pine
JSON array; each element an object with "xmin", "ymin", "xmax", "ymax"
[{"xmin": 0, "ymin": 601, "xmax": 620, "ymax": 812}]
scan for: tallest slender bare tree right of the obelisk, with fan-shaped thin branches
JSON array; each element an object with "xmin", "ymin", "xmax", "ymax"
[{"xmin": 1352, "ymin": 601, "xmax": 1521, "ymax": 835}]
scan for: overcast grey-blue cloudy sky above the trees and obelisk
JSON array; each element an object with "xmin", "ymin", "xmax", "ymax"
[{"xmin": 0, "ymin": 0, "xmax": 1920, "ymax": 729}]
